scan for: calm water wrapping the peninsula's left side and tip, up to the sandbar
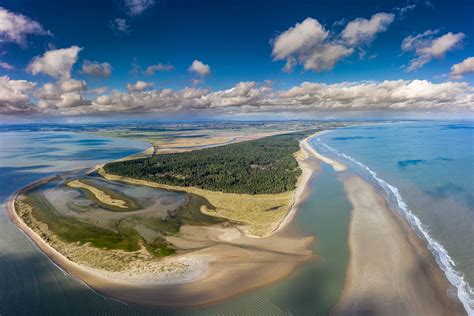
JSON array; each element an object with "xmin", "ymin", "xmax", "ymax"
[{"xmin": 0, "ymin": 132, "xmax": 351, "ymax": 316}]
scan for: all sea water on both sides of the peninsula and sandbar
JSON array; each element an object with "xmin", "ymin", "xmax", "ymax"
[{"xmin": 0, "ymin": 122, "xmax": 474, "ymax": 316}]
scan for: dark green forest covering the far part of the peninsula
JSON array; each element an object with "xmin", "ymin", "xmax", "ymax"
[{"xmin": 104, "ymin": 130, "xmax": 316, "ymax": 194}]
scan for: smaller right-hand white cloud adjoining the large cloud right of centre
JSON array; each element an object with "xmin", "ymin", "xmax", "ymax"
[{"xmin": 341, "ymin": 12, "xmax": 395, "ymax": 46}]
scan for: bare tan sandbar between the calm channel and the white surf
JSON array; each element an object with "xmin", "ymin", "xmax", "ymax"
[{"xmin": 334, "ymin": 176, "xmax": 465, "ymax": 315}]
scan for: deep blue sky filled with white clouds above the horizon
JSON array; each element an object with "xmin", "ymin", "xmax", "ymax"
[{"xmin": 0, "ymin": 0, "xmax": 474, "ymax": 122}]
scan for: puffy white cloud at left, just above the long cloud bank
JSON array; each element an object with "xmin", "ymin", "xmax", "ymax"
[{"xmin": 27, "ymin": 46, "xmax": 82, "ymax": 79}]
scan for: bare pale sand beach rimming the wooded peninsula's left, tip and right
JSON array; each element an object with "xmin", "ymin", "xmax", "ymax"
[{"xmin": 6, "ymin": 132, "xmax": 316, "ymax": 306}]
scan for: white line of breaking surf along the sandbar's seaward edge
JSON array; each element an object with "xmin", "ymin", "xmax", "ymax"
[{"xmin": 313, "ymin": 134, "xmax": 474, "ymax": 316}]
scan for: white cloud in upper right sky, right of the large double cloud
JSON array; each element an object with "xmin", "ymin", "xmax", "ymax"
[{"xmin": 401, "ymin": 30, "xmax": 465, "ymax": 72}]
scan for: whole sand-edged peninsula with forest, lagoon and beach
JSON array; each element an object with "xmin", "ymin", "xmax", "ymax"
[{"xmin": 9, "ymin": 130, "xmax": 318, "ymax": 306}]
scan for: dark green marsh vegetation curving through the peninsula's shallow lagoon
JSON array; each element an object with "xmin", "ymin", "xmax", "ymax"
[{"xmin": 19, "ymin": 184, "xmax": 224, "ymax": 257}]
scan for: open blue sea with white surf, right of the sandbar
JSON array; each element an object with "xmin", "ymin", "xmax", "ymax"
[{"xmin": 314, "ymin": 122, "xmax": 474, "ymax": 313}]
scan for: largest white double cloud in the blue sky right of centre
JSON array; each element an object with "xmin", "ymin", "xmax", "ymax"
[{"xmin": 272, "ymin": 13, "xmax": 394, "ymax": 72}]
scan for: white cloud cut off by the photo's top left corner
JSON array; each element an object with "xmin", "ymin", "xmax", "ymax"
[{"xmin": 0, "ymin": 7, "xmax": 52, "ymax": 46}]
